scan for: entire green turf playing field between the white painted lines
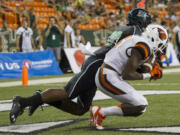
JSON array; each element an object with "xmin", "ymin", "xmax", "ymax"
[{"xmin": 0, "ymin": 73, "xmax": 180, "ymax": 135}]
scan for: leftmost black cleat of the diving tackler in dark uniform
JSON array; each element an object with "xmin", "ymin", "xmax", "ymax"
[{"xmin": 9, "ymin": 96, "xmax": 24, "ymax": 124}]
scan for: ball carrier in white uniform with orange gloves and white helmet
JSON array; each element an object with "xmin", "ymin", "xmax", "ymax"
[{"xmin": 90, "ymin": 24, "xmax": 168, "ymax": 129}]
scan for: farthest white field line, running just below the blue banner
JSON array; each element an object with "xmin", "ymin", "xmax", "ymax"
[{"xmin": 0, "ymin": 68, "xmax": 180, "ymax": 87}]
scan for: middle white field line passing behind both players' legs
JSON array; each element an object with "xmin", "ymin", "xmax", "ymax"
[{"xmin": 0, "ymin": 90, "xmax": 180, "ymax": 112}]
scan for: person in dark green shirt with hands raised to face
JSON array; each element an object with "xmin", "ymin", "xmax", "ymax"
[{"xmin": 45, "ymin": 17, "xmax": 63, "ymax": 63}]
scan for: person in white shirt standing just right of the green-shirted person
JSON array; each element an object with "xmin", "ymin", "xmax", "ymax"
[{"xmin": 64, "ymin": 20, "xmax": 76, "ymax": 48}]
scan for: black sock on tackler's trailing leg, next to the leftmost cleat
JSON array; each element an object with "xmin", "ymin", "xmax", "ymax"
[{"xmin": 20, "ymin": 93, "xmax": 43, "ymax": 107}]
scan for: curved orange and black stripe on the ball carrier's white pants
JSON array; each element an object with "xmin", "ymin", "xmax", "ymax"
[{"xmin": 99, "ymin": 67, "xmax": 125, "ymax": 95}]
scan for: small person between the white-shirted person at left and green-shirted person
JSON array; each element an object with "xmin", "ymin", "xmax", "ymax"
[{"xmin": 35, "ymin": 29, "xmax": 44, "ymax": 51}]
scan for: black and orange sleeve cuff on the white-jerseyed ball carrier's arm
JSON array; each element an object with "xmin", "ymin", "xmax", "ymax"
[{"xmin": 134, "ymin": 42, "xmax": 151, "ymax": 59}]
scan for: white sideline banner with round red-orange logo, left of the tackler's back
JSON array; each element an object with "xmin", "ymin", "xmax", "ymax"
[{"xmin": 64, "ymin": 47, "xmax": 99, "ymax": 73}]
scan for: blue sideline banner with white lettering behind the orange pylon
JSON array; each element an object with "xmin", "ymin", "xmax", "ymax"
[{"xmin": 0, "ymin": 50, "xmax": 63, "ymax": 79}]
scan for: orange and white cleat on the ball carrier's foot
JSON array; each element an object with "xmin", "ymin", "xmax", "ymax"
[{"xmin": 90, "ymin": 106, "xmax": 105, "ymax": 130}]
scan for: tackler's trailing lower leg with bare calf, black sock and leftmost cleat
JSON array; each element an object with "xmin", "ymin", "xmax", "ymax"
[{"xmin": 10, "ymin": 89, "xmax": 68, "ymax": 123}]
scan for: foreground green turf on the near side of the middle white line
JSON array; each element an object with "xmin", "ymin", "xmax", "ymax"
[{"xmin": 0, "ymin": 95, "xmax": 180, "ymax": 135}]
